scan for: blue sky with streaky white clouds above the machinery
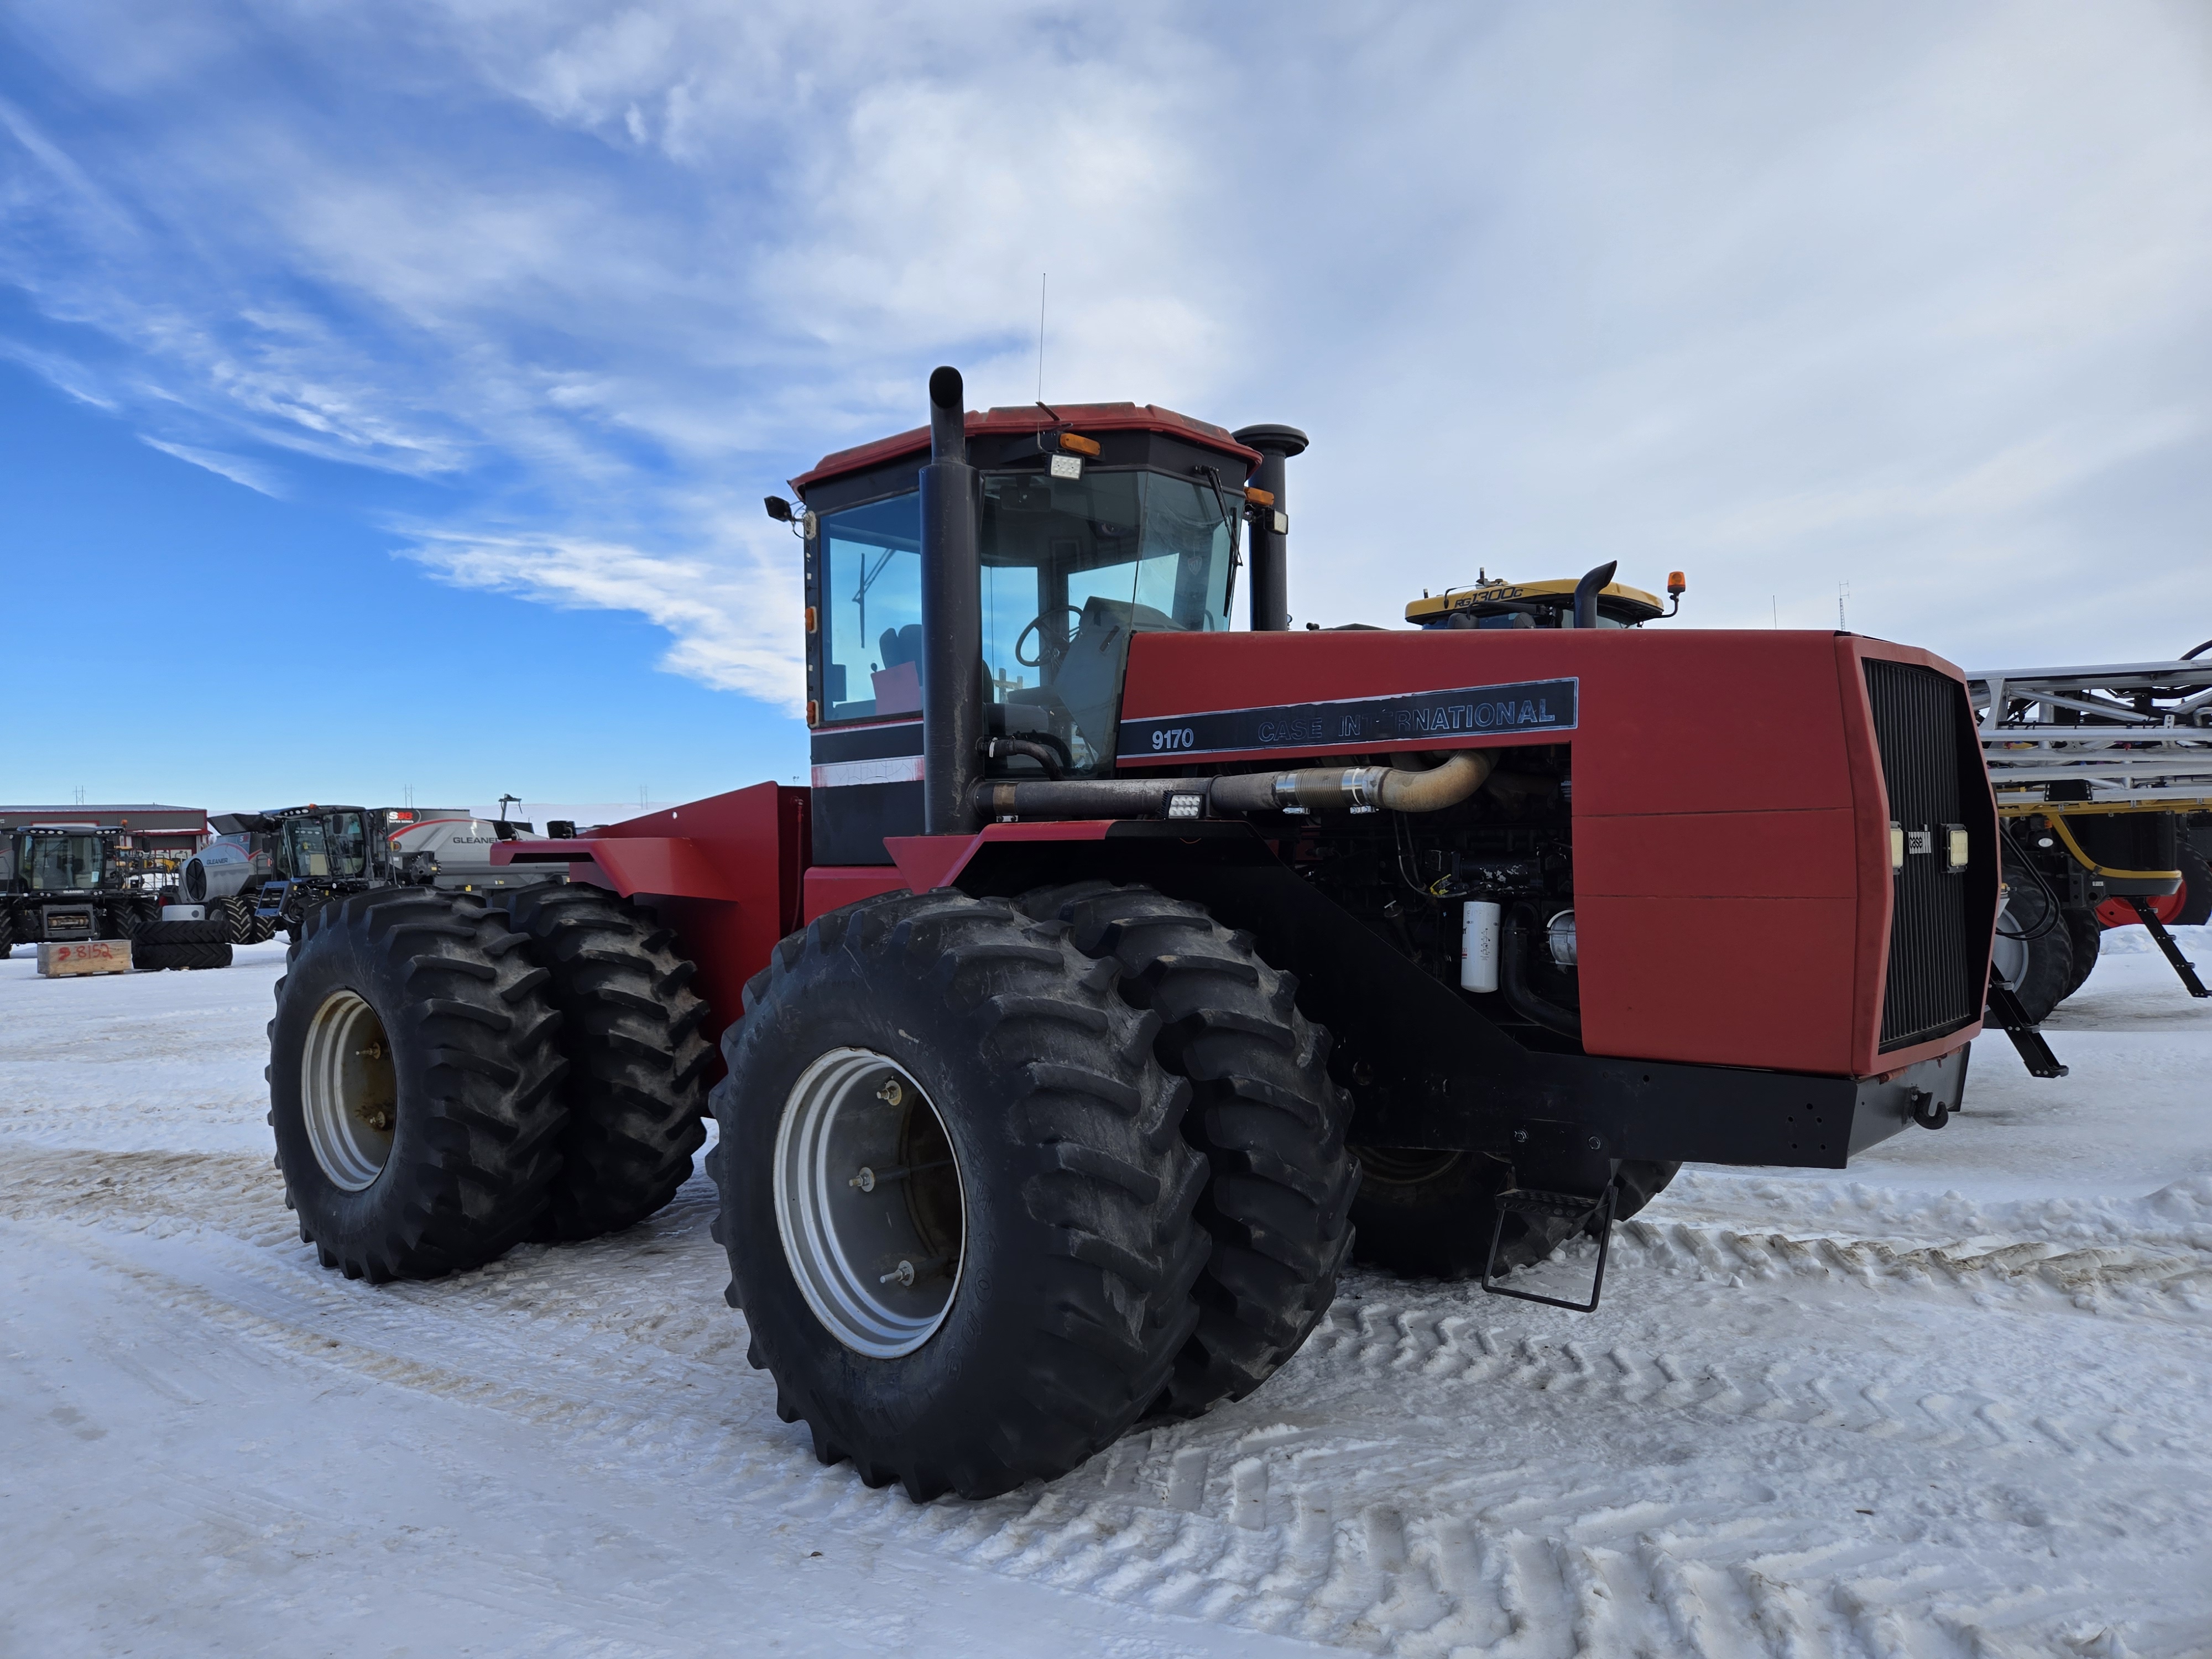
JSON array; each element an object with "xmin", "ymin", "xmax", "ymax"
[{"xmin": 0, "ymin": 0, "xmax": 2212, "ymax": 807}]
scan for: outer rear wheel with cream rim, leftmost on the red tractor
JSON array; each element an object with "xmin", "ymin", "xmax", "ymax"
[{"xmin": 268, "ymin": 887, "xmax": 566, "ymax": 1283}]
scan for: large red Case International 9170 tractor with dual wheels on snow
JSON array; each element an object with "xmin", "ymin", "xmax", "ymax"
[{"xmin": 270, "ymin": 369, "xmax": 1997, "ymax": 1500}]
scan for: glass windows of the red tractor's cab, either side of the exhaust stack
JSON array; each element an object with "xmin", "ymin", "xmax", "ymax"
[{"xmin": 821, "ymin": 471, "xmax": 1241, "ymax": 770}]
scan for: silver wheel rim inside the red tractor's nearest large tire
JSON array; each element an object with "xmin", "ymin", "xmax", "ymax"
[{"xmin": 774, "ymin": 1048, "xmax": 967, "ymax": 1360}]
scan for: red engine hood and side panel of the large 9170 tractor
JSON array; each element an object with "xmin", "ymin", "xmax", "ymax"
[{"xmin": 1121, "ymin": 628, "xmax": 1995, "ymax": 1075}]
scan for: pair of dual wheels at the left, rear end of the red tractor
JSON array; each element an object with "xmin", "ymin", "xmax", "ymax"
[{"xmin": 269, "ymin": 887, "xmax": 712, "ymax": 1283}]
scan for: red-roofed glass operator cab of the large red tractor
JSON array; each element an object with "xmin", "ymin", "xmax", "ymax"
[{"xmin": 787, "ymin": 403, "xmax": 1274, "ymax": 863}]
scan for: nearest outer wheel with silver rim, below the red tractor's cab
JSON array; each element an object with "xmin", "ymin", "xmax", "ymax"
[{"xmin": 708, "ymin": 891, "xmax": 1208, "ymax": 1502}]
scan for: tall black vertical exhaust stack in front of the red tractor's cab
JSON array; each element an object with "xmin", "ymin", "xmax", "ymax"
[{"xmin": 922, "ymin": 367, "xmax": 982, "ymax": 836}]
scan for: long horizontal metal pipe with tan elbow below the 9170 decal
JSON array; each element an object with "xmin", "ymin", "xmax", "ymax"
[{"xmin": 973, "ymin": 750, "xmax": 1495, "ymax": 818}]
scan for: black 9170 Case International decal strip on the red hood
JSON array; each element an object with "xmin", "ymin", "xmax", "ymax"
[{"xmin": 1117, "ymin": 679, "xmax": 1579, "ymax": 763}]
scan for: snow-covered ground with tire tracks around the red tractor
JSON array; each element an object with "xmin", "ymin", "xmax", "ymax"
[{"xmin": 0, "ymin": 929, "xmax": 2212, "ymax": 1659}]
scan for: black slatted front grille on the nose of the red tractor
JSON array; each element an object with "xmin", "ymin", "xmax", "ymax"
[{"xmin": 1867, "ymin": 657, "xmax": 1995, "ymax": 1053}]
